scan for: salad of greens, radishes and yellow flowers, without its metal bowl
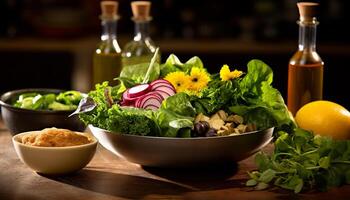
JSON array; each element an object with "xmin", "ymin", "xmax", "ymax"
[{"xmin": 77, "ymin": 55, "xmax": 294, "ymax": 138}]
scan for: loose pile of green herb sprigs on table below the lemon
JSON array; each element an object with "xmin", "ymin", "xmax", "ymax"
[{"xmin": 246, "ymin": 128, "xmax": 350, "ymax": 193}]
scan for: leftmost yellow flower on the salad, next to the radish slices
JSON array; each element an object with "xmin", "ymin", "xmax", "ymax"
[{"xmin": 164, "ymin": 71, "xmax": 190, "ymax": 92}]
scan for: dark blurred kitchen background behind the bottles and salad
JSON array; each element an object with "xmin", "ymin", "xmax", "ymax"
[{"xmin": 0, "ymin": 0, "xmax": 350, "ymax": 108}]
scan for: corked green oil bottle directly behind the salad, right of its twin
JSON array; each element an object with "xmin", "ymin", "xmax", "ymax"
[{"xmin": 122, "ymin": 1, "xmax": 160, "ymax": 67}]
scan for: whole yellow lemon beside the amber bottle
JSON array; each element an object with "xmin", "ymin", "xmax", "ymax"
[{"xmin": 295, "ymin": 100, "xmax": 350, "ymax": 139}]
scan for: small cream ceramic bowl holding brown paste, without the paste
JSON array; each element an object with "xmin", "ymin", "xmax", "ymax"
[{"xmin": 12, "ymin": 131, "xmax": 97, "ymax": 175}]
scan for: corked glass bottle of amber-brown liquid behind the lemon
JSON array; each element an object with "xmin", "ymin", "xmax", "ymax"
[{"xmin": 287, "ymin": 2, "xmax": 324, "ymax": 115}]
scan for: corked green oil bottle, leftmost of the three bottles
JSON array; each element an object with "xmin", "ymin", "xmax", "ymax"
[{"xmin": 92, "ymin": 1, "xmax": 121, "ymax": 86}]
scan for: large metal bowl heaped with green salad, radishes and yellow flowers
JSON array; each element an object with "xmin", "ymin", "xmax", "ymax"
[{"xmin": 75, "ymin": 55, "xmax": 293, "ymax": 167}]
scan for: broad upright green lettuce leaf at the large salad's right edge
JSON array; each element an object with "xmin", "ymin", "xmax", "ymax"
[{"xmin": 230, "ymin": 60, "xmax": 295, "ymax": 129}]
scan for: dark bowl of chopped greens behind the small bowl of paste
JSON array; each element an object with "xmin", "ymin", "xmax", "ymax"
[{"xmin": 0, "ymin": 88, "xmax": 86, "ymax": 134}]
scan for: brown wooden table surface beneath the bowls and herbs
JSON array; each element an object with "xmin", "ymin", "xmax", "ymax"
[{"xmin": 0, "ymin": 120, "xmax": 350, "ymax": 200}]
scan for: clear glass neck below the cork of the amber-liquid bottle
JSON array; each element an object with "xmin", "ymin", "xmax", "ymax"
[{"xmin": 298, "ymin": 20, "xmax": 318, "ymax": 51}]
